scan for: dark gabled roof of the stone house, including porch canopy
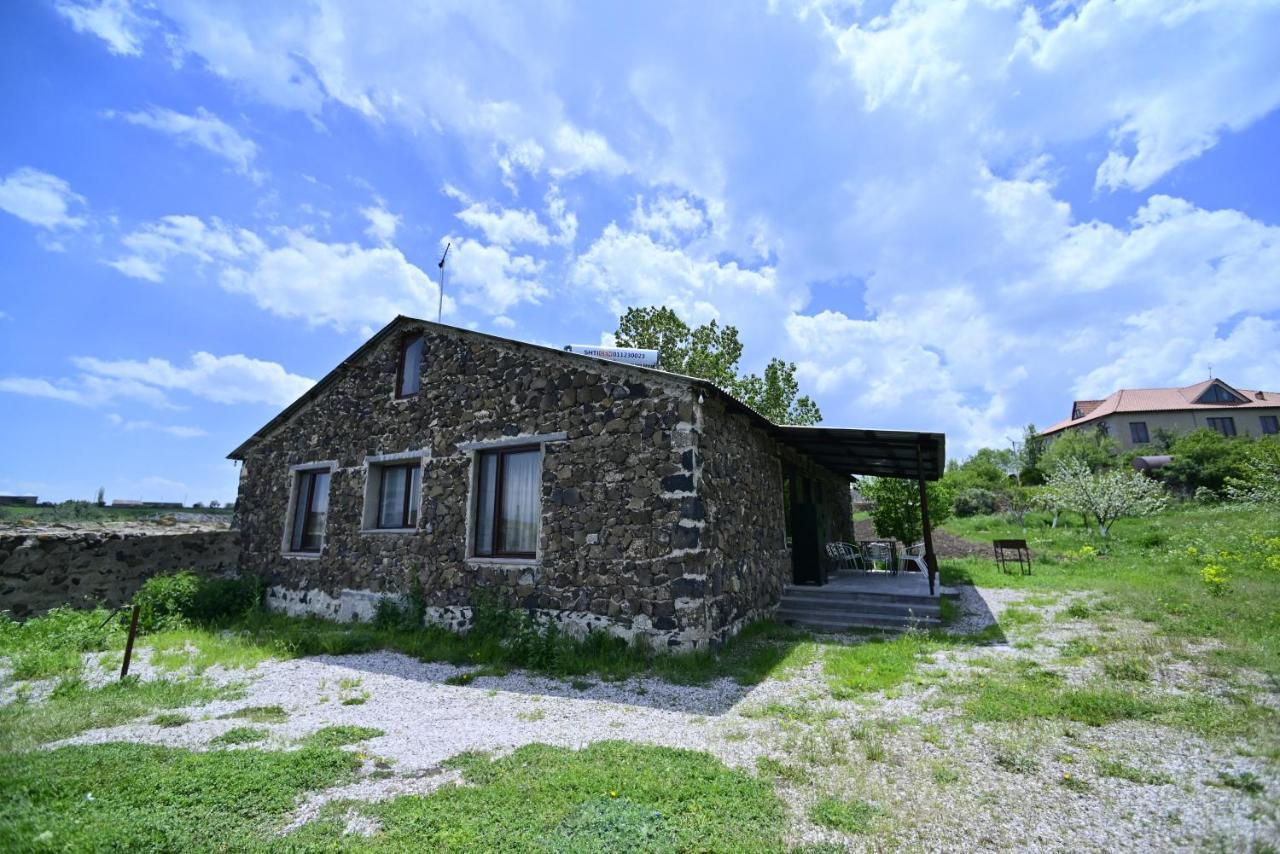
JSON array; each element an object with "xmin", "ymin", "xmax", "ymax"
[{"xmin": 227, "ymin": 315, "xmax": 946, "ymax": 480}]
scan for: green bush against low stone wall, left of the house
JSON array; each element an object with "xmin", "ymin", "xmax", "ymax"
[{"xmin": 133, "ymin": 570, "xmax": 262, "ymax": 632}]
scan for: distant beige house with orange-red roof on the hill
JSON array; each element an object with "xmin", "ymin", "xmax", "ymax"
[{"xmin": 1041, "ymin": 379, "xmax": 1280, "ymax": 448}]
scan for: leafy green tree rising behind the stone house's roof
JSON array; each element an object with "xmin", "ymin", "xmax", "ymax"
[{"xmin": 614, "ymin": 306, "xmax": 822, "ymax": 424}]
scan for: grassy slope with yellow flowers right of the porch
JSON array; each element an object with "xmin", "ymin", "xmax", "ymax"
[{"xmin": 942, "ymin": 503, "xmax": 1280, "ymax": 677}]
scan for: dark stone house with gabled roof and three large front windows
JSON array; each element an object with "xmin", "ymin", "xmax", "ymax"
[{"xmin": 230, "ymin": 316, "xmax": 942, "ymax": 649}]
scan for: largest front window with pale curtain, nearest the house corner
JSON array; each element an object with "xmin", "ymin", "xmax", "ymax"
[{"xmin": 475, "ymin": 447, "xmax": 543, "ymax": 557}]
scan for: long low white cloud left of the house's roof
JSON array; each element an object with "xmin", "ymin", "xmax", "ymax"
[{"xmin": 0, "ymin": 352, "xmax": 315, "ymax": 408}]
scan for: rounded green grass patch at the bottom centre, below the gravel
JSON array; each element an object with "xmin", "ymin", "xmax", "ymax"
[{"xmin": 289, "ymin": 741, "xmax": 786, "ymax": 853}]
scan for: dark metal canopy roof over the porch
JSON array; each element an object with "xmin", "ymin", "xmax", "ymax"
[{"xmin": 772, "ymin": 425, "xmax": 947, "ymax": 480}]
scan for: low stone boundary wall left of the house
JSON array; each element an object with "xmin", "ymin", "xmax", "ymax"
[{"xmin": 0, "ymin": 530, "xmax": 239, "ymax": 620}]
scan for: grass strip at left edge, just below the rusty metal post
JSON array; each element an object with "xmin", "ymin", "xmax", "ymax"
[{"xmin": 0, "ymin": 677, "xmax": 238, "ymax": 753}]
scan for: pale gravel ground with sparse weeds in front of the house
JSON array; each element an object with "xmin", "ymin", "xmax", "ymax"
[{"xmin": 12, "ymin": 588, "xmax": 1280, "ymax": 851}]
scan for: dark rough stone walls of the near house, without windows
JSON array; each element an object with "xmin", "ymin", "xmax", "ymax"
[{"xmin": 237, "ymin": 324, "xmax": 855, "ymax": 648}]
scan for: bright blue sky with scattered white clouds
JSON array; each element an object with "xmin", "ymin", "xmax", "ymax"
[{"xmin": 0, "ymin": 0, "xmax": 1280, "ymax": 501}]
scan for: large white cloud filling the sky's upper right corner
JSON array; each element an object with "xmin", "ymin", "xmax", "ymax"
[{"xmin": 828, "ymin": 0, "xmax": 1280, "ymax": 189}]
